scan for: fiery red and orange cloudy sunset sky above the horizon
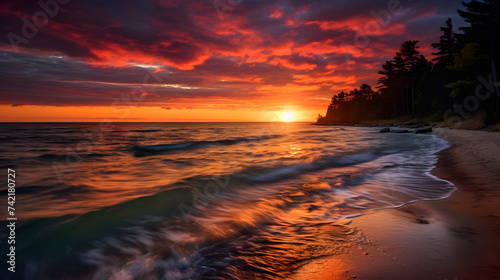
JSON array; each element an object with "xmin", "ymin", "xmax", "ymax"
[{"xmin": 0, "ymin": 0, "xmax": 464, "ymax": 122}]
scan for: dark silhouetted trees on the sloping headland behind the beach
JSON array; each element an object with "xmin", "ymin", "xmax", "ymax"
[{"xmin": 317, "ymin": 0, "xmax": 500, "ymax": 126}]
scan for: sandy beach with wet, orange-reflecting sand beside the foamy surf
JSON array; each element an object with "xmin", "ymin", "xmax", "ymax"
[{"xmin": 291, "ymin": 129, "xmax": 500, "ymax": 280}]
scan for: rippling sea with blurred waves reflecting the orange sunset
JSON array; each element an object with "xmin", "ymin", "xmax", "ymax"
[{"xmin": 0, "ymin": 123, "xmax": 455, "ymax": 279}]
